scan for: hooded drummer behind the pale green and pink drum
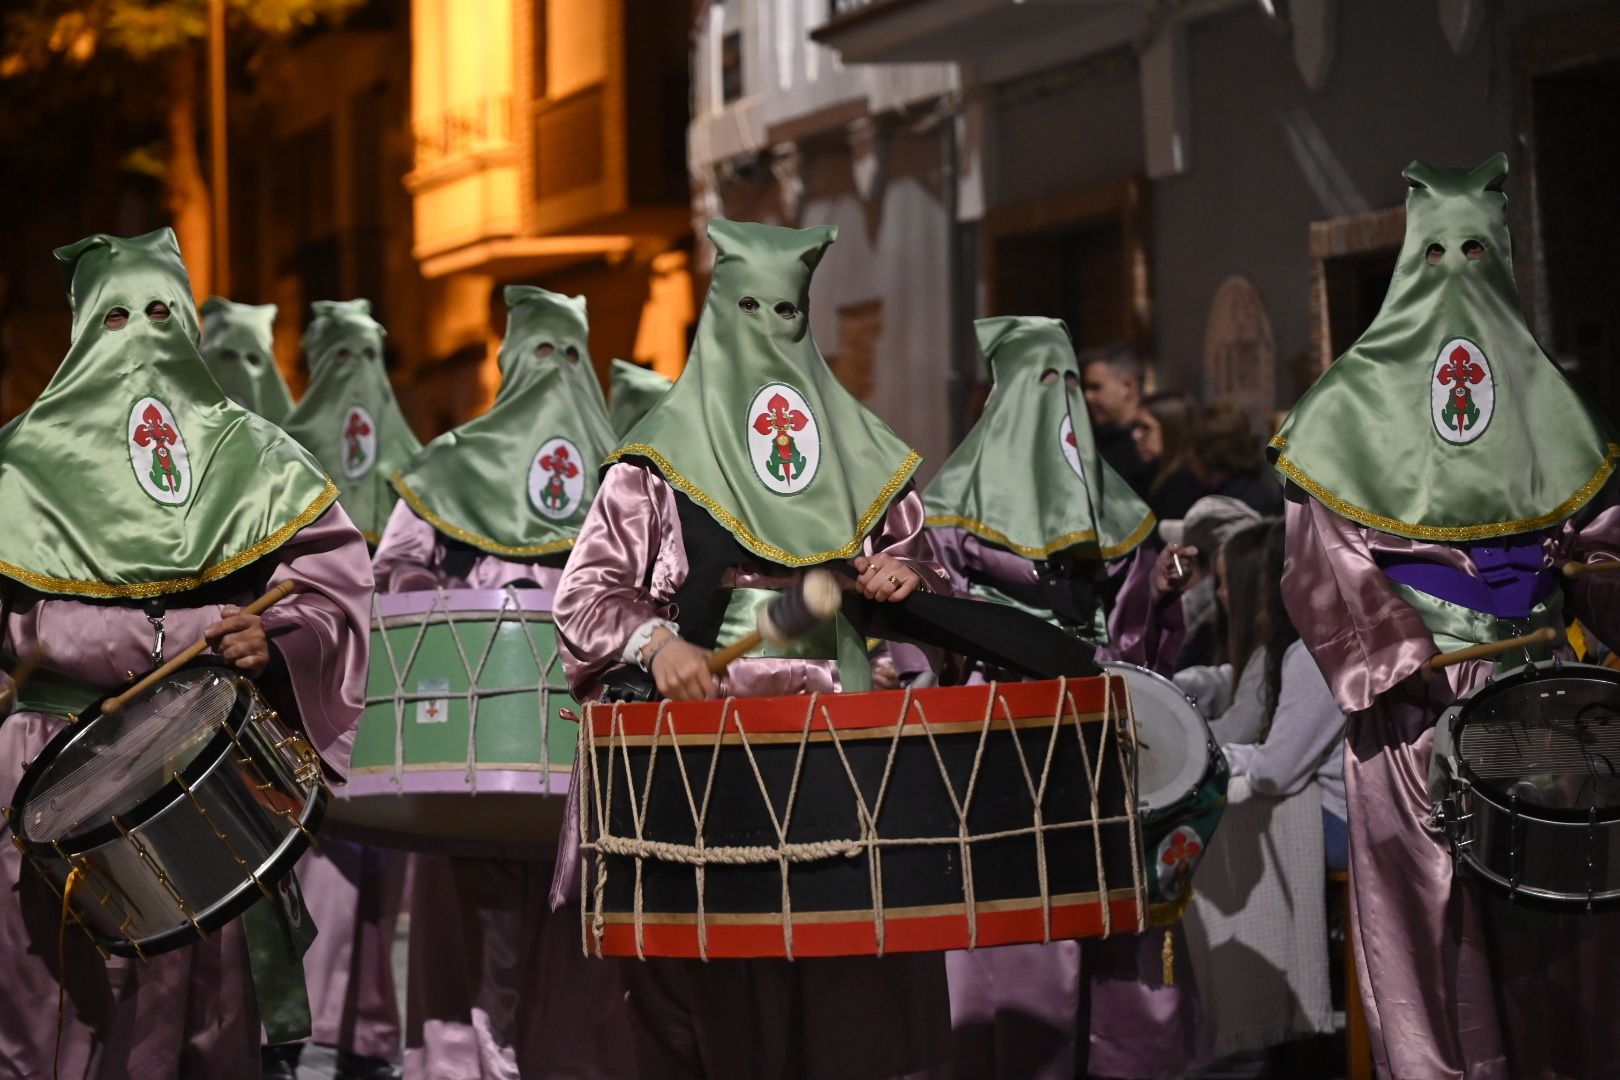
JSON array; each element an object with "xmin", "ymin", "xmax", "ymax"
[{"xmin": 376, "ymin": 285, "xmax": 633, "ymax": 1080}]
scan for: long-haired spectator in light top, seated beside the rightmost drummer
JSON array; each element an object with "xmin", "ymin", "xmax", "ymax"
[{"xmin": 1176, "ymin": 518, "xmax": 1349, "ymax": 870}]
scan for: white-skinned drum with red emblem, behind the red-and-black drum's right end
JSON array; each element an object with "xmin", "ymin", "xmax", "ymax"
[{"xmin": 1100, "ymin": 661, "xmax": 1231, "ymax": 925}]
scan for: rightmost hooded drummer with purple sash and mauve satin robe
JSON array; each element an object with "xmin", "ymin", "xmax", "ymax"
[{"xmin": 1270, "ymin": 154, "xmax": 1620, "ymax": 1080}]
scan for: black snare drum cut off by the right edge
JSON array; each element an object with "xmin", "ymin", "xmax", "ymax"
[{"xmin": 1435, "ymin": 661, "xmax": 1620, "ymax": 912}]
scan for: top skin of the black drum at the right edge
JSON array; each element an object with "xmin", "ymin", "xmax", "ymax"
[{"xmin": 1450, "ymin": 662, "xmax": 1620, "ymax": 821}]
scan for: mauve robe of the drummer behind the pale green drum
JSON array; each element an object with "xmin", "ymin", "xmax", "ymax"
[{"xmin": 374, "ymin": 502, "xmax": 635, "ymax": 1080}]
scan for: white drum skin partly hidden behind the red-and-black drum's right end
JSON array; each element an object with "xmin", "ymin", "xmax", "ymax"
[{"xmin": 1102, "ymin": 661, "xmax": 1210, "ymax": 814}]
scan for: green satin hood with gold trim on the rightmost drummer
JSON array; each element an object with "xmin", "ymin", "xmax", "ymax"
[{"xmin": 1270, "ymin": 154, "xmax": 1620, "ymax": 541}]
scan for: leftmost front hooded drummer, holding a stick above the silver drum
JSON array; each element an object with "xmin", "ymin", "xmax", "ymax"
[{"xmin": 0, "ymin": 228, "xmax": 371, "ymax": 1080}]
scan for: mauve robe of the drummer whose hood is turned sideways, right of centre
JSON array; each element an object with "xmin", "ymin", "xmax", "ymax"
[{"xmin": 928, "ymin": 528, "xmax": 1210, "ymax": 1080}]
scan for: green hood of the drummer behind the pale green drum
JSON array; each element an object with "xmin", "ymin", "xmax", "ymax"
[{"xmin": 394, "ymin": 285, "xmax": 617, "ymax": 557}]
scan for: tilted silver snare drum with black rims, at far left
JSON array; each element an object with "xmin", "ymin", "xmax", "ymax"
[{"xmin": 6, "ymin": 659, "xmax": 326, "ymax": 957}]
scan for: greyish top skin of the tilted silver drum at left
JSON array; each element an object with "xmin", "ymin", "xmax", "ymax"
[{"xmin": 19, "ymin": 665, "xmax": 243, "ymax": 844}]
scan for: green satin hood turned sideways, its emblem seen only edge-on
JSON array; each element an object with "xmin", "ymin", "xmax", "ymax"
[{"xmin": 923, "ymin": 316, "xmax": 1153, "ymax": 559}]
